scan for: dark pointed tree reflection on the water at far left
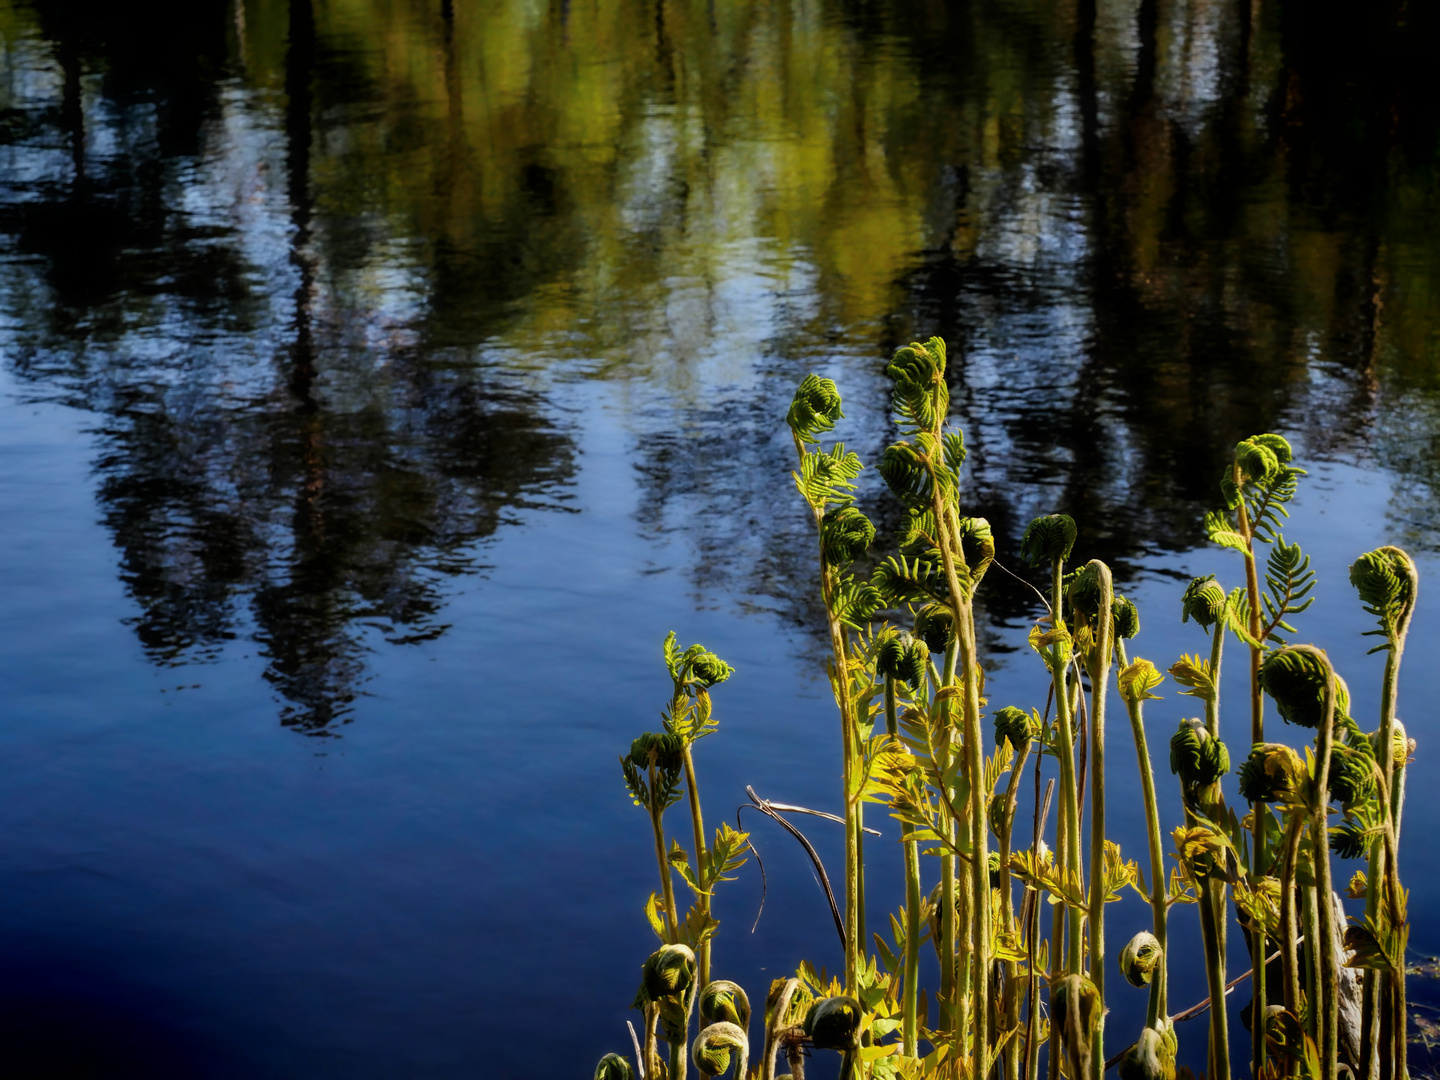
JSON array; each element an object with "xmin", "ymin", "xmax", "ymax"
[{"xmin": 3, "ymin": 4, "xmax": 573, "ymax": 733}]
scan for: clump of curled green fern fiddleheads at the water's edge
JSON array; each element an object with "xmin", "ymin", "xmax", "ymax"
[{"xmin": 595, "ymin": 337, "xmax": 1418, "ymax": 1080}]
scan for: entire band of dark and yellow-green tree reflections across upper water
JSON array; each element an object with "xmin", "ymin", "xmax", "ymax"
[{"xmin": 0, "ymin": 0, "xmax": 1440, "ymax": 730}]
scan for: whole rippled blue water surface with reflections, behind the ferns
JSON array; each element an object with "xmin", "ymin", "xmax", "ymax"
[{"xmin": 0, "ymin": 0, "xmax": 1440, "ymax": 1079}]
